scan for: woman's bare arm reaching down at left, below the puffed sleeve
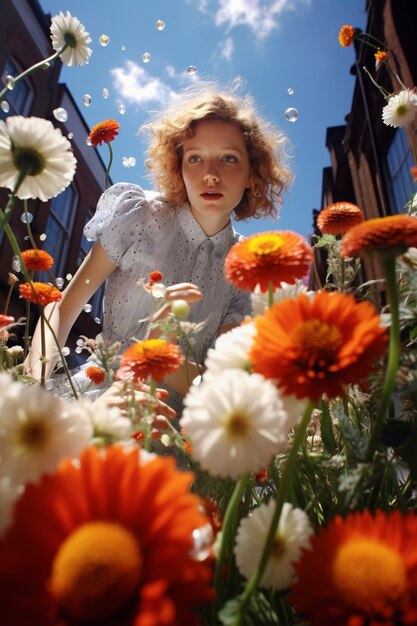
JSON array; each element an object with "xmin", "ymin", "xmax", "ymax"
[{"xmin": 25, "ymin": 242, "xmax": 116, "ymax": 380}]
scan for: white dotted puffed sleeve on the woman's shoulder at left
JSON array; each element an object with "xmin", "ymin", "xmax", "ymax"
[{"xmin": 84, "ymin": 183, "xmax": 171, "ymax": 270}]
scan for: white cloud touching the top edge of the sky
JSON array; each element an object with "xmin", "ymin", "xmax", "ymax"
[{"xmin": 207, "ymin": 0, "xmax": 311, "ymax": 39}]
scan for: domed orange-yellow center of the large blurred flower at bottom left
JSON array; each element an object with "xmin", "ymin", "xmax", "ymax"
[{"xmin": 50, "ymin": 522, "xmax": 143, "ymax": 621}]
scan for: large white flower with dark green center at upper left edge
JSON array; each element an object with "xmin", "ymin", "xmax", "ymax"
[{"xmin": 0, "ymin": 115, "xmax": 76, "ymax": 202}]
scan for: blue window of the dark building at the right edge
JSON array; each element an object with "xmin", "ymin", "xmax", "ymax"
[{"xmin": 387, "ymin": 128, "xmax": 414, "ymax": 213}]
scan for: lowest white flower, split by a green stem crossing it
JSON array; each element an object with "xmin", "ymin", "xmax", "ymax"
[{"xmin": 234, "ymin": 500, "xmax": 313, "ymax": 590}]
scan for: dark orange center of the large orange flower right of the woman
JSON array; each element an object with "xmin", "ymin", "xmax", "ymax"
[{"xmin": 291, "ymin": 319, "xmax": 343, "ymax": 369}]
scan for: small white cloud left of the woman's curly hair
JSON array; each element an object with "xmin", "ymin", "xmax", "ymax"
[{"xmin": 110, "ymin": 60, "xmax": 176, "ymax": 106}]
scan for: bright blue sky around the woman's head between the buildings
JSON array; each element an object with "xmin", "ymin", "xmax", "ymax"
[{"xmin": 40, "ymin": 0, "xmax": 366, "ymax": 235}]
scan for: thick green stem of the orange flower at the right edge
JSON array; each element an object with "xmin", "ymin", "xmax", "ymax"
[{"xmin": 367, "ymin": 256, "xmax": 401, "ymax": 459}]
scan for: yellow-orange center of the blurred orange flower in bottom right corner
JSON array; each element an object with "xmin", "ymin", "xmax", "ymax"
[{"xmin": 333, "ymin": 539, "xmax": 406, "ymax": 611}]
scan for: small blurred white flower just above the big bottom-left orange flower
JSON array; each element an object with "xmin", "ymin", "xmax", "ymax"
[{"xmin": 77, "ymin": 398, "xmax": 134, "ymax": 441}]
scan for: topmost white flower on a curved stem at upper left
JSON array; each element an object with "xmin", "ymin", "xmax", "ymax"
[{"xmin": 51, "ymin": 11, "xmax": 92, "ymax": 67}]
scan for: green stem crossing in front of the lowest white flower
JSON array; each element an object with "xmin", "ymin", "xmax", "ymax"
[{"xmin": 233, "ymin": 402, "xmax": 314, "ymax": 626}]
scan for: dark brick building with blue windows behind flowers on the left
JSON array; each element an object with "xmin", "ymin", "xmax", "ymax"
[{"xmin": 0, "ymin": 0, "xmax": 106, "ymax": 358}]
